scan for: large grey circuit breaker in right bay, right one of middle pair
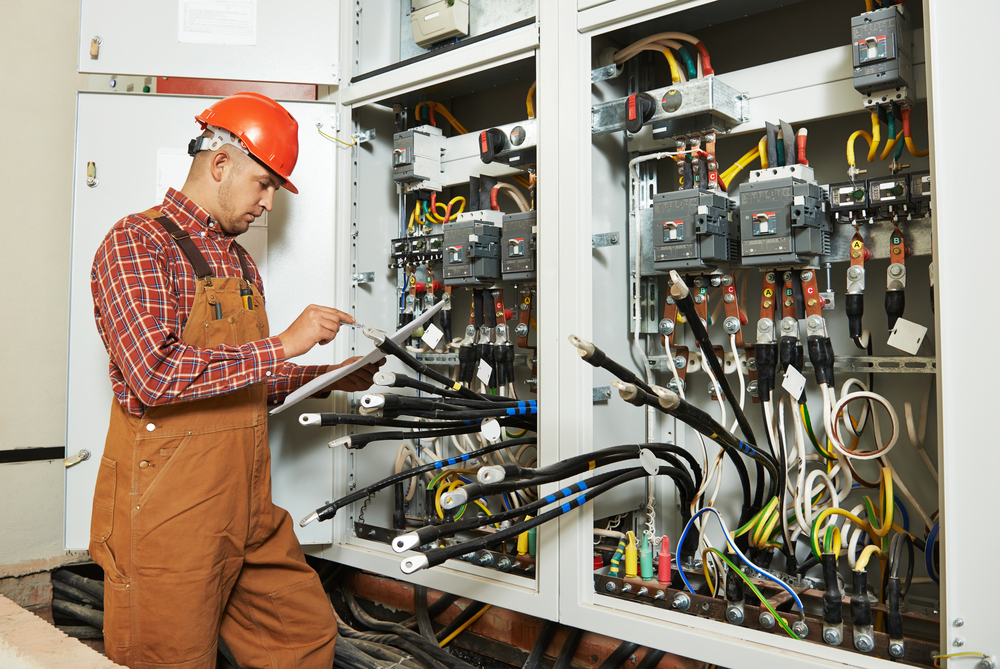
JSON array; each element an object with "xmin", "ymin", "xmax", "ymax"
[{"xmin": 739, "ymin": 165, "xmax": 831, "ymax": 267}]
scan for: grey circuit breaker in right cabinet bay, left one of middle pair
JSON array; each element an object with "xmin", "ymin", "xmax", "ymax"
[{"xmin": 653, "ymin": 189, "xmax": 739, "ymax": 272}]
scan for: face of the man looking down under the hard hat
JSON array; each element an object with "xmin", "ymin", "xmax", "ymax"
[{"xmin": 216, "ymin": 155, "xmax": 281, "ymax": 236}]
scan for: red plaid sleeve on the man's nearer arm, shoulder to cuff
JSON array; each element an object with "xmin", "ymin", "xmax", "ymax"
[{"xmin": 93, "ymin": 222, "xmax": 288, "ymax": 406}]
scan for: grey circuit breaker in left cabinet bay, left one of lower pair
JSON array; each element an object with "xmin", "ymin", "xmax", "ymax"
[{"xmin": 443, "ymin": 211, "xmax": 503, "ymax": 286}]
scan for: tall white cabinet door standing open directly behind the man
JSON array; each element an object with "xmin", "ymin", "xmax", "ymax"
[{"xmin": 66, "ymin": 93, "xmax": 349, "ymax": 549}]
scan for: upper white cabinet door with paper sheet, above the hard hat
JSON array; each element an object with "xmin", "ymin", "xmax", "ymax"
[{"xmin": 79, "ymin": 0, "xmax": 339, "ymax": 84}]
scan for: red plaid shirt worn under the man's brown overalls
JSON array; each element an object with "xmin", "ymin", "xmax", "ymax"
[{"xmin": 90, "ymin": 188, "xmax": 328, "ymax": 416}]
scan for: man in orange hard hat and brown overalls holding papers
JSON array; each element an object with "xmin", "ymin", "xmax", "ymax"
[{"xmin": 90, "ymin": 93, "xmax": 377, "ymax": 669}]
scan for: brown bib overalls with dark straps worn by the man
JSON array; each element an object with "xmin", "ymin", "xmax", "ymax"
[{"xmin": 90, "ymin": 210, "xmax": 337, "ymax": 669}]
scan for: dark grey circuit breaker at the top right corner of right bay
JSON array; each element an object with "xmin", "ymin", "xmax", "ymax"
[{"xmin": 851, "ymin": 5, "xmax": 913, "ymax": 95}]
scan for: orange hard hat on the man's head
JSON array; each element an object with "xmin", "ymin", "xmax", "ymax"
[{"xmin": 195, "ymin": 93, "xmax": 299, "ymax": 193}]
